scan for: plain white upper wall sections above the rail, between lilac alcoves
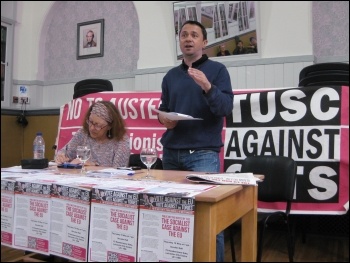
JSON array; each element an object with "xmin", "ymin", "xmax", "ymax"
[{"xmin": 13, "ymin": 1, "xmax": 312, "ymax": 81}]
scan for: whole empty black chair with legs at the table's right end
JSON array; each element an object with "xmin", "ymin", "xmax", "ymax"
[{"xmin": 229, "ymin": 156, "xmax": 297, "ymax": 262}]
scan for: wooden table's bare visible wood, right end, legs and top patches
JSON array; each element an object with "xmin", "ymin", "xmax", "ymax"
[{"xmin": 78, "ymin": 166, "xmax": 258, "ymax": 262}]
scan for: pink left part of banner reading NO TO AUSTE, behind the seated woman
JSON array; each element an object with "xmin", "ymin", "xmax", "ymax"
[{"xmin": 57, "ymin": 92, "xmax": 165, "ymax": 157}]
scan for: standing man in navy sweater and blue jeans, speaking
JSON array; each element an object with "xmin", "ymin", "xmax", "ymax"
[{"xmin": 158, "ymin": 20, "xmax": 233, "ymax": 262}]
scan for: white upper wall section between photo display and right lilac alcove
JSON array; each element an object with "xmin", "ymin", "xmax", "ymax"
[{"xmin": 259, "ymin": 1, "xmax": 313, "ymax": 58}]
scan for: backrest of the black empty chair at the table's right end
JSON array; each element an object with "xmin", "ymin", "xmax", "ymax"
[{"xmin": 241, "ymin": 156, "xmax": 297, "ymax": 205}]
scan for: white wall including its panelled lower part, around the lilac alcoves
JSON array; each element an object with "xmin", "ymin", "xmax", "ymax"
[{"xmin": 6, "ymin": 1, "xmax": 336, "ymax": 110}]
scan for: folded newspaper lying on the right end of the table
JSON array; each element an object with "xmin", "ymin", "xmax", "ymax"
[{"xmin": 186, "ymin": 173, "xmax": 258, "ymax": 185}]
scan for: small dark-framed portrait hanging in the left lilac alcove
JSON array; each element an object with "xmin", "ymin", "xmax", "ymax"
[{"xmin": 77, "ymin": 19, "xmax": 104, "ymax": 59}]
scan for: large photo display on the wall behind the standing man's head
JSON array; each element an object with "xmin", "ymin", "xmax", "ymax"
[{"xmin": 173, "ymin": 1, "xmax": 261, "ymax": 60}]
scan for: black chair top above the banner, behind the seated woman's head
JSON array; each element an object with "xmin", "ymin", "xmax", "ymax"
[{"xmin": 73, "ymin": 79, "xmax": 113, "ymax": 99}]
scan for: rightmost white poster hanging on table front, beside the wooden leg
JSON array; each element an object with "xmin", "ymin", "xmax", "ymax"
[{"xmin": 137, "ymin": 189, "xmax": 195, "ymax": 262}]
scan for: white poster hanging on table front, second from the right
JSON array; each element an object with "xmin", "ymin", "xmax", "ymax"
[{"xmin": 88, "ymin": 187, "xmax": 139, "ymax": 262}]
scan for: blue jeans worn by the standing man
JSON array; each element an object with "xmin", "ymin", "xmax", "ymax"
[{"xmin": 163, "ymin": 148, "xmax": 225, "ymax": 262}]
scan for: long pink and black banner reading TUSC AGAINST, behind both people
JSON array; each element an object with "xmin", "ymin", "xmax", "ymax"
[{"xmin": 56, "ymin": 87, "xmax": 349, "ymax": 214}]
